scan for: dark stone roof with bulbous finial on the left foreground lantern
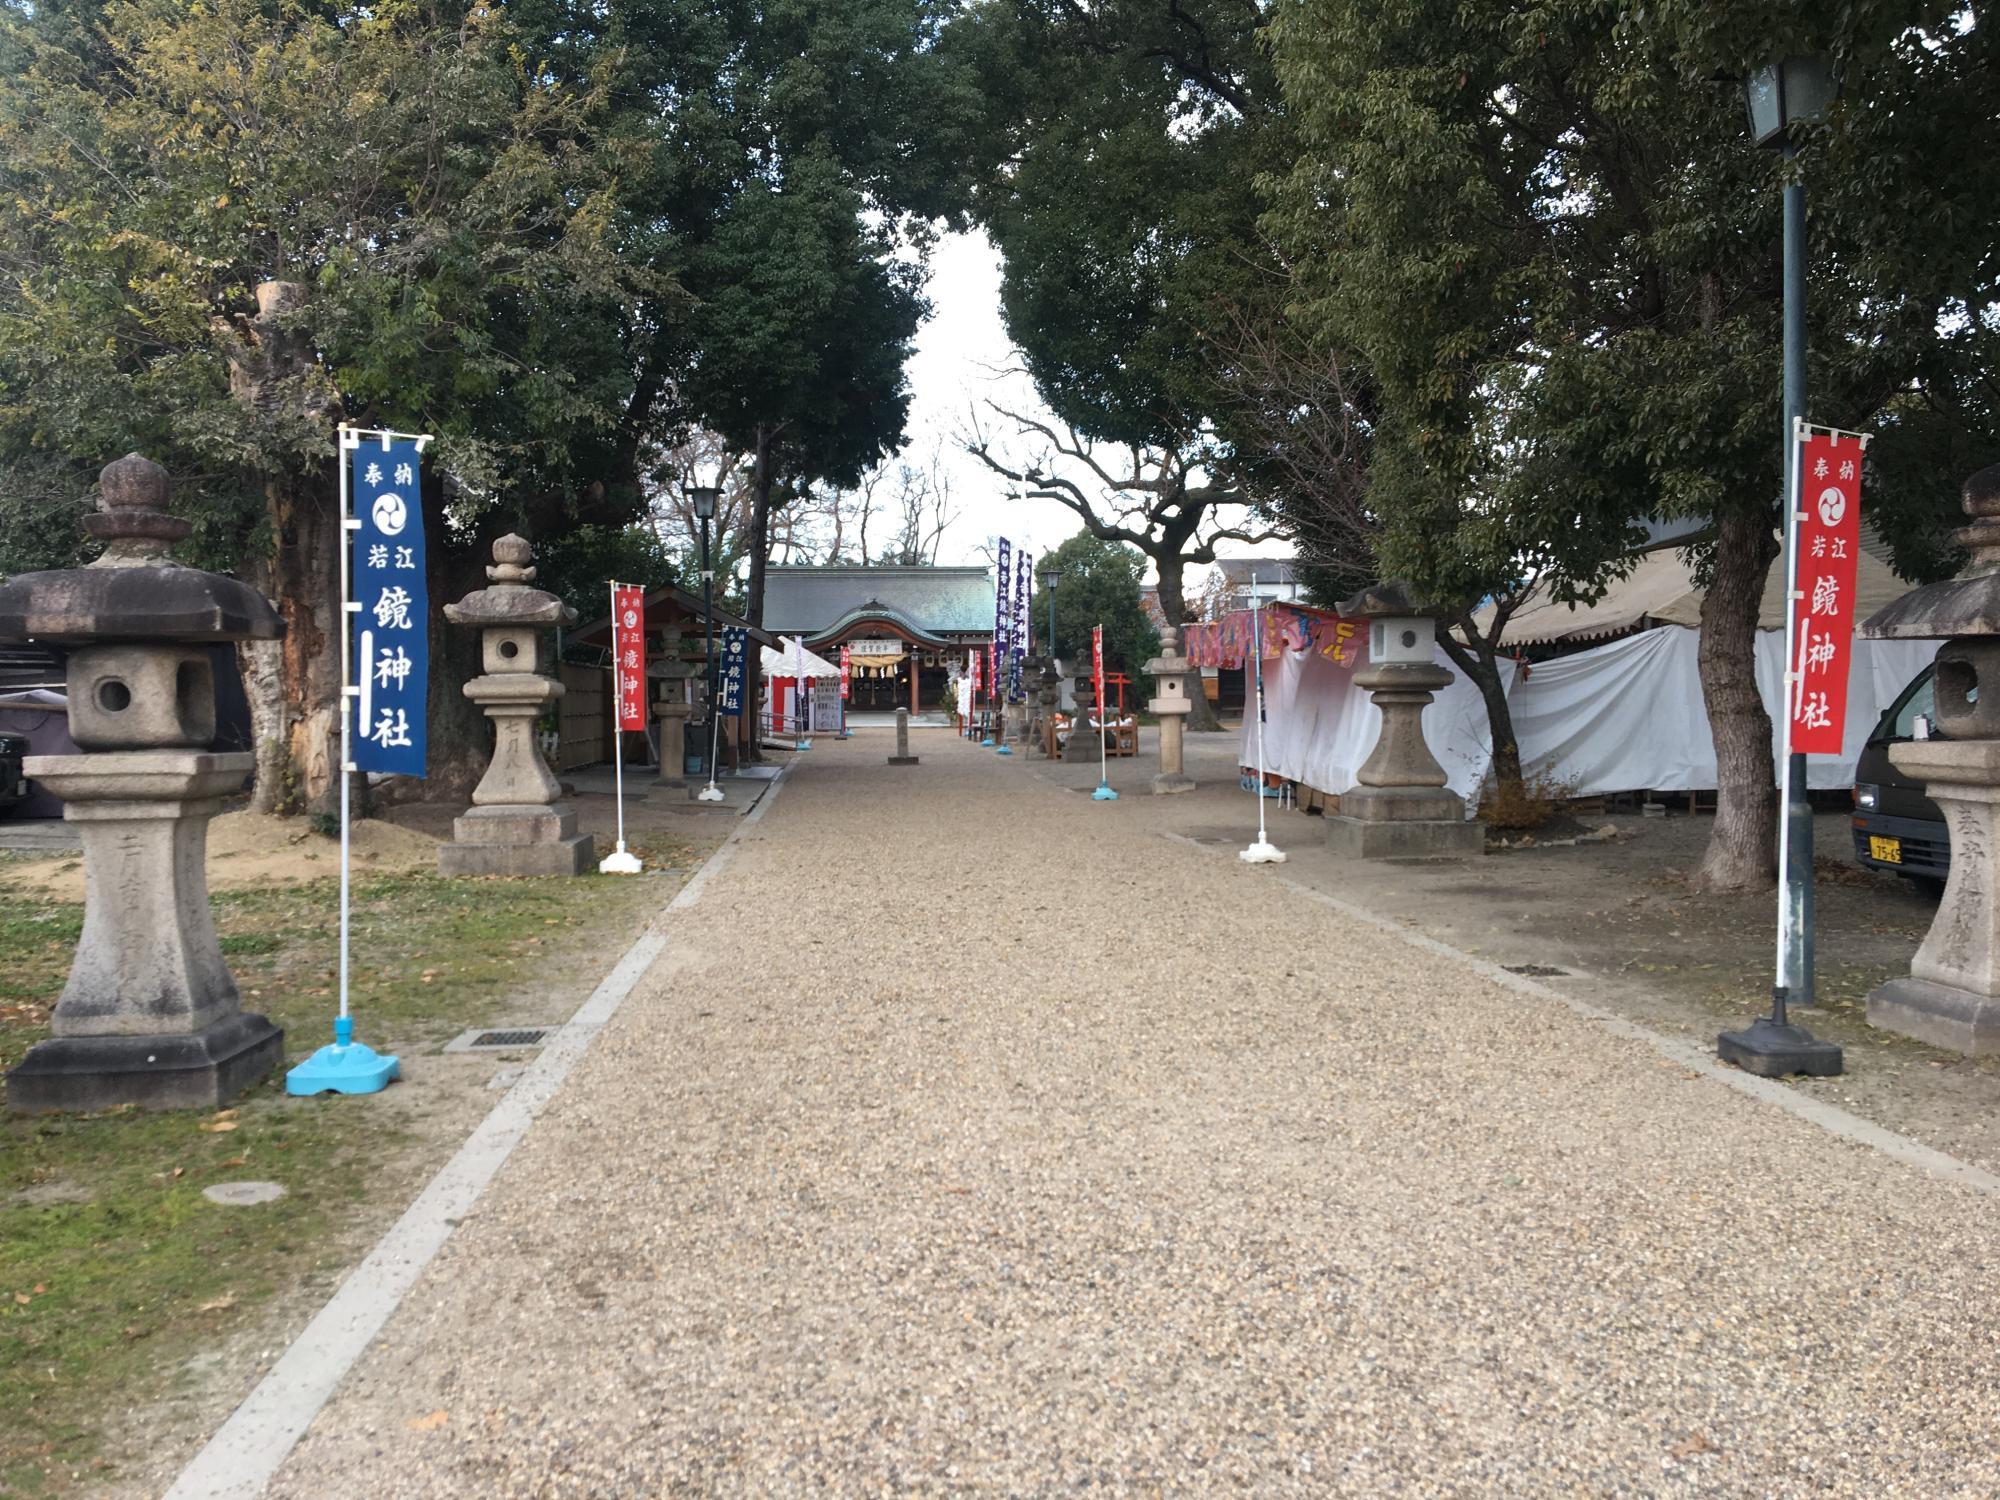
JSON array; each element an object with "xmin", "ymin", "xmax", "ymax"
[{"xmin": 0, "ymin": 454, "xmax": 284, "ymax": 646}]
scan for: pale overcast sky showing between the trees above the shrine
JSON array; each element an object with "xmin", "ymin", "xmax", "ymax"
[{"xmin": 904, "ymin": 232, "xmax": 1292, "ymax": 592}]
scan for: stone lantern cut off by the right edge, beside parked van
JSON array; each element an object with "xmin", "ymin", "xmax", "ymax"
[{"xmin": 1862, "ymin": 464, "xmax": 2000, "ymax": 1054}]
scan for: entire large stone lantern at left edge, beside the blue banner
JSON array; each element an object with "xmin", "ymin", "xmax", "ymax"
[{"xmin": 0, "ymin": 454, "xmax": 284, "ymax": 1110}]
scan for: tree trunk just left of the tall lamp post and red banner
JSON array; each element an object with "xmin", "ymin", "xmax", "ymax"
[{"xmin": 1694, "ymin": 510, "xmax": 1778, "ymax": 890}]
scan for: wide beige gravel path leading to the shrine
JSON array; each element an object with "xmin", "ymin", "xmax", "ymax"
[{"xmin": 272, "ymin": 732, "xmax": 2000, "ymax": 1500}]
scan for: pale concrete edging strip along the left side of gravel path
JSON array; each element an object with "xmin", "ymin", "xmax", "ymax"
[{"xmin": 164, "ymin": 774, "xmax": 784, "ymax": 1500}]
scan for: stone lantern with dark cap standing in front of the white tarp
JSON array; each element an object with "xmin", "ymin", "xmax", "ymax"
[{"xmin": 1326, "ymin": 584, "xmax": 1486, "ymax": 860}]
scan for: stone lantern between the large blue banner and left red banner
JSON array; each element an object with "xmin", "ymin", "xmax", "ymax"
[{"xmin": 438, "ymin": 536, "xmax": 596, "ymax": 876}]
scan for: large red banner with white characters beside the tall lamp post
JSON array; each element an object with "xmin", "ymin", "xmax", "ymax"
[{"xmin": 1786, "ymin": 432, "xmax": 1864, "ymax": 756}]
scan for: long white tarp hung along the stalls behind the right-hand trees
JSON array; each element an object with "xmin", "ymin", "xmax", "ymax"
[{"xmin": 1240, "ymin": 626, "xmax": 1936, "ymax": 800}]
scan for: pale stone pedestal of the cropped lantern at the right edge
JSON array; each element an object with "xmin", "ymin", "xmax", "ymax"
[{"xmin": 1868, "ymin": 740, "xmax": 2000, "ymax": 1056}]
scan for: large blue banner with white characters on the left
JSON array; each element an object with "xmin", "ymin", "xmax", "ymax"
[{"xmin": 348, "ymin": 440, "xmax": 430, "ymax": 776}]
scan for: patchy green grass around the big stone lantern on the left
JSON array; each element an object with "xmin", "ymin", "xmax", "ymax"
[{"xmin": 0, "ymin": 836, "xmax": 706, "ymax": 1496}]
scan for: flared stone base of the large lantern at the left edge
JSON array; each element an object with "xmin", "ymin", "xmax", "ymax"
[{"xmin": 6, "ymin": 750, "xmax": 284, "ymax": 1112}]
